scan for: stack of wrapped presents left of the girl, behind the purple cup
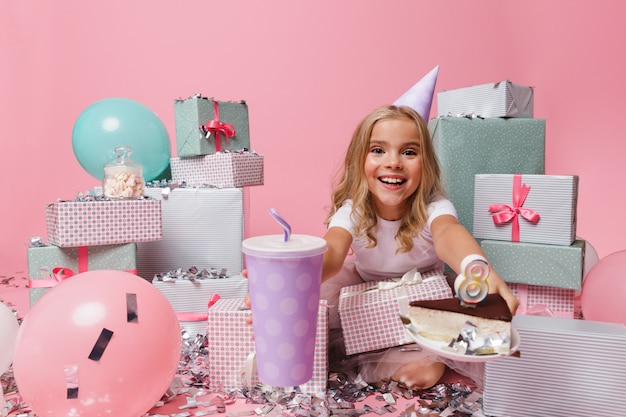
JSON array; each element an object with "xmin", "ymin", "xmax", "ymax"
[{"xmin": 27, "ymin": 95, "xmax": 328, "ymax": 394}]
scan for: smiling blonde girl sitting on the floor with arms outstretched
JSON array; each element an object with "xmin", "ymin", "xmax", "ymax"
[{"xmin": 321, "ymin": 106, "xmax": 518, "ymax": 389}]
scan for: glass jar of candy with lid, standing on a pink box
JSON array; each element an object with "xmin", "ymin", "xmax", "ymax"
[{"xmin": 102, "ymin": 146, "xmax": 145, "ymax": 200}]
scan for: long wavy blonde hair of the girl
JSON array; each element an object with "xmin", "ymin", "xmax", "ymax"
[{"xmin": 326, "ymin": 106, "xmax": 445, "ymax": 253}]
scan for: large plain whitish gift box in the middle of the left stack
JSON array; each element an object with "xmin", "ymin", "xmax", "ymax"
[{"xmin": 137, "ymin": 187, "xmax": 244, "ymax": 281}]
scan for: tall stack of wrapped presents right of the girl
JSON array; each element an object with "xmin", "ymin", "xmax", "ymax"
[{"xmin": 429, "ymin": 81, "xmax": 626, "ymax": 417}]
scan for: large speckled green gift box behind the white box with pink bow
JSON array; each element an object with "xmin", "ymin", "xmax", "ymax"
[{"xmin": 428, "ymin": 117, "xmax": 546, "ymax": 233}]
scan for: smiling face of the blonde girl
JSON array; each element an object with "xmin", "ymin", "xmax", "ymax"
[{"xmin": 364, "ymin": 118, "xmax": 422, "ymax": 220}]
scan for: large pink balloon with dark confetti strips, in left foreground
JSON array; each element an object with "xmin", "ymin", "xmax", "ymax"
[{"xmin": 13, "ymin": 270, "xmax": 181, "ymax": 417}]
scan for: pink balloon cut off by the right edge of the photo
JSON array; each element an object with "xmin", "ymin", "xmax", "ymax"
[{"xmin": 581, "ymin": 250, "xmax": 626, "ymax": 324}]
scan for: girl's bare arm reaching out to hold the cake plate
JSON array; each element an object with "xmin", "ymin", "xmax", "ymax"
[{"xmin": 430, "ymin": 215, "xmax": 519, "ymax": 314}]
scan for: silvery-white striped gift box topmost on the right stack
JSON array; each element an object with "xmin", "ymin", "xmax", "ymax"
[{"xmin": 437, "ymin": 80, "xmax": 534, "ymax": 118}]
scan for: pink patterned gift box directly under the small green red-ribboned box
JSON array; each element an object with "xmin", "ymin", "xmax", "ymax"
[{"xmin": 170, "ymin": 151, "xmax": 263, "ymax": 188}]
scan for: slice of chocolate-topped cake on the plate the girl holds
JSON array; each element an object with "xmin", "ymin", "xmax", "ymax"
[{"xmin": 409, "ymin": 294, "xmax": 513, "ymax": 354}]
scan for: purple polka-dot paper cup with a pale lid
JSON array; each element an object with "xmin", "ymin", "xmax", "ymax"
[{"xmin": 242, "ymin": 234, "xmax": 327, "ymax": 387}]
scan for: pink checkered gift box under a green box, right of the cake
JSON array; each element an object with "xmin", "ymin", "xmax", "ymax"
[{"xmin": 507, "ymin": 283, "xmax": 576, "ymax": 319}]
